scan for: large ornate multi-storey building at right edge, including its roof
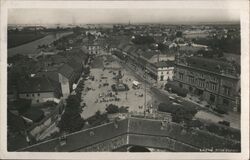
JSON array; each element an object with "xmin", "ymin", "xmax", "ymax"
[{"xmin": 174, "ymin": 55, "xmax": 240, "ymax": 111}]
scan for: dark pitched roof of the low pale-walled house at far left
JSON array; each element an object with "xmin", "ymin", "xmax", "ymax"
[{"xmin": 18, "ymin": 77, "xmax": 54, "ymax": 93}]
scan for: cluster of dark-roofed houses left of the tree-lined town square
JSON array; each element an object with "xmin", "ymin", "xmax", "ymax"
[{"xmin": 8, "ymin": 49, "xmax": 88, "ymax": 104}]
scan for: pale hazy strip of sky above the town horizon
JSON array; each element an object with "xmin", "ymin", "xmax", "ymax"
[{"xmin": 8, "ymin": 8, "xmax": 240, "ymax": 25}]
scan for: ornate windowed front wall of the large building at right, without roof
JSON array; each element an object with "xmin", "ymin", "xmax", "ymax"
[{"xmin": 174, "ymin": 62, "xmax": 240, "ymax": 111}]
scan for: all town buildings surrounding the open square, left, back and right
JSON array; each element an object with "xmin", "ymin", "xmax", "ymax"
[{"xmin": 8, "ymin": 25, "xmax": 240, "ymax": 150}]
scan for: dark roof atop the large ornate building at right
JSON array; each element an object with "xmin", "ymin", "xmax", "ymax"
[{"xmin": 187, "ymin": 56, "xmax": 234, "ymax": 73}]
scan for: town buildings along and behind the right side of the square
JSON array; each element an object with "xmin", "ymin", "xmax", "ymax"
[{"xmin": 104, "ymin": 26, "xmax": 240, "ymax": 111}]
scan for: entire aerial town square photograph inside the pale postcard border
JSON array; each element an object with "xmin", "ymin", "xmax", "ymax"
[{"xmin": 7, "ymin": 6, "xmax": 242, "ymax": 153}]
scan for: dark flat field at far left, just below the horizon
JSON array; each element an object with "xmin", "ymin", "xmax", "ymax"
[{"xmin": 8, "ymin": 32, "xmax": 46, "ymax": 48}]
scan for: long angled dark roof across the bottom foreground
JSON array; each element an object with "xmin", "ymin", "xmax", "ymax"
[{"xmin": 21, "ymin": 118, "xmax": 240, "ymax": 152}]
